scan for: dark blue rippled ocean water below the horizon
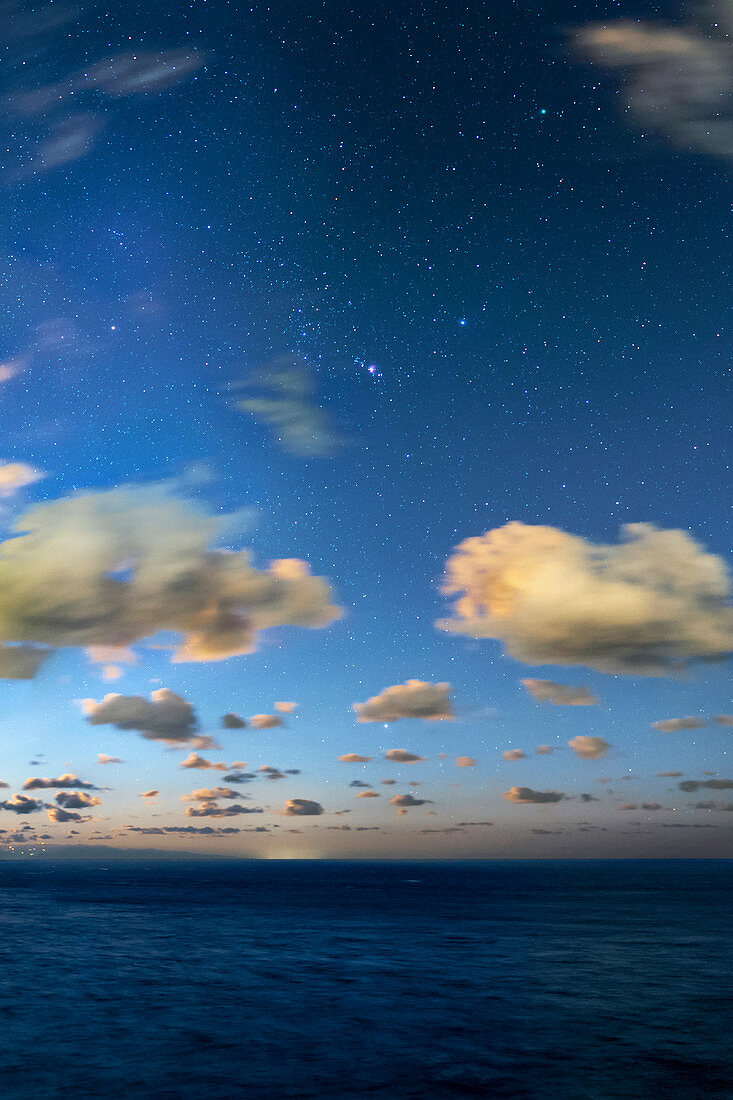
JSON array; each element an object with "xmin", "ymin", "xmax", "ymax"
[{"xmin": 0, "ymin": 860, "xmax": 733, "ymax": 1100}]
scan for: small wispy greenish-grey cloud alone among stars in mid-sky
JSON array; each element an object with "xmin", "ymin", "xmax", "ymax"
[{"xmin": 237, "ymin": 356, "xmax": 341, "ymax": 459}]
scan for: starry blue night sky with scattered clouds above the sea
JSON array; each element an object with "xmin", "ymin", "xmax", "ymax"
[{"xmin": 0, "ymin": 0, "xmax": 733, "ymax": 858}]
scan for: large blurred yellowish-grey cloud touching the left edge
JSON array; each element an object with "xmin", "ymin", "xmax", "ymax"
[{"xmin": 0, "ymin": 485, "xmax": 340, "ymax": 661}]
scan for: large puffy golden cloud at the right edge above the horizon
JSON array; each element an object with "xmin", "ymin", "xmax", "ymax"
[{"xmin": 437, "ymin": 523, "xmax": 733, "ymax": 675}]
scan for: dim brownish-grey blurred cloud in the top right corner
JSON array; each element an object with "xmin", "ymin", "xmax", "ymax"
[{"xmin": 573, "ymin": 11, "xmax": 733, "ymax": 160}]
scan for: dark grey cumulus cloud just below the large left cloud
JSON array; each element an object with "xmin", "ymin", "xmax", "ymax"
[{"xmin": 83, "ymin": 688, "xmax": 197, "ymax": 745}]
